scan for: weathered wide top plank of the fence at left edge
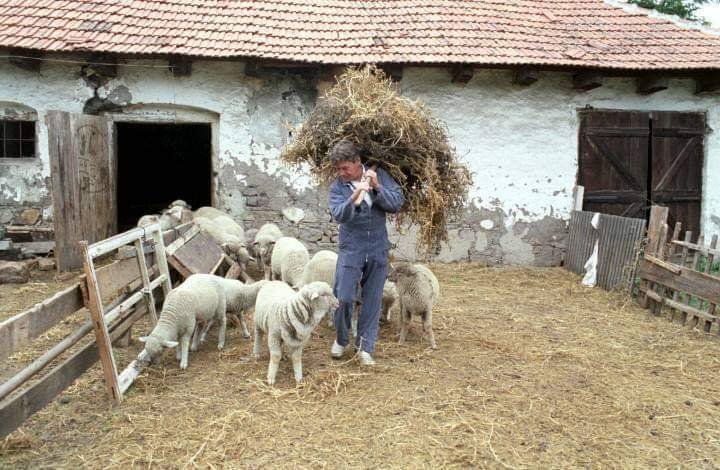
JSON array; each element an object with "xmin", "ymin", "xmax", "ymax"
[{"xmin": 0, "ymin": 284, "xmax": 84, "ymax": 360}]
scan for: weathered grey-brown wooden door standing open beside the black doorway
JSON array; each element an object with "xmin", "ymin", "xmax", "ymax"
[{"xmin": 46, "ymin": 111, "xmax": 117, "ymax": 271}]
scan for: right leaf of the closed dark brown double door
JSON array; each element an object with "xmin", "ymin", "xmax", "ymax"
[{"xmin": 650, "ymin": 112, "xmax": 705, "ymax": 234}]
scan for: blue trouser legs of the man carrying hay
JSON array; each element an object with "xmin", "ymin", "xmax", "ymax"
[{"xmin": 334, "ymin": 260, "xmax": 387, "ymax": 353}]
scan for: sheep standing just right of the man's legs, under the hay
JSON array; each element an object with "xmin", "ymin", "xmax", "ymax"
[{"xmin": 393, "ymin": 263, "xmax": 440, "ymax": 349}]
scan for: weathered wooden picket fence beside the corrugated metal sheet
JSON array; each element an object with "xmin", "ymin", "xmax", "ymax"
[{"xmin": 638, "ymin": 206, "xmax": 720, "ymax": 334}]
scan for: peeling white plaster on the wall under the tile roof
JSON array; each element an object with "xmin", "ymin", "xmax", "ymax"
[{"xmin": 0, "ymin": 60, "xmax": 720, "ymax": 255}]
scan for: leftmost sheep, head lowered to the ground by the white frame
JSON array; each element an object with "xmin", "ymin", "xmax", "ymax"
[{"xmin": 138, "ymin": 274, "xmax": 227, "ymax": 370}]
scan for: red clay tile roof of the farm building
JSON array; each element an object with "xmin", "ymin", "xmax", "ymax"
[{"xmin": 0, "ymin": 0, "xmax": 720, "ymax": 69}]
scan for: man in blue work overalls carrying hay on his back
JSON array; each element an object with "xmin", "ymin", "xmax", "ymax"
[{"xmin": 329, "ymin": 140, "xmax": 405, "ymax": 365}]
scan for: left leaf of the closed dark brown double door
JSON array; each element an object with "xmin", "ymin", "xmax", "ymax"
[{"xmin": 578, "ymin": 111, "xmax": 650, "ymax": 218}]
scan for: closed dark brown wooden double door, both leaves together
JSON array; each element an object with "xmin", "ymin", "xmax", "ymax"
[{"xmin": 578, "ymin": 111, "xmax": 705, "ymax": 233}]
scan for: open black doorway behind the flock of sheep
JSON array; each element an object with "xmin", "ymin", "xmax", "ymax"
[{"xmin": 116, "ymin": 123, "xmax": 212, "ymax": 231}]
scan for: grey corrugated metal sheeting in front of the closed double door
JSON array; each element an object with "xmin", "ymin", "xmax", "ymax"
[{"xmin": 565, "ymin": 211, "xmax": 645, "ymax": 290}]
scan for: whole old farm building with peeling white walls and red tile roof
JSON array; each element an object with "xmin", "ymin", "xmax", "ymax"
[{"xmin": 0, "ymin": 0, "xmax": 720, "ymax": 266}]
